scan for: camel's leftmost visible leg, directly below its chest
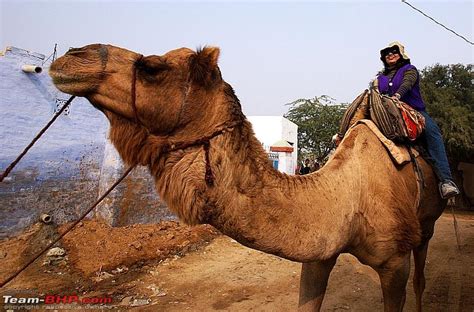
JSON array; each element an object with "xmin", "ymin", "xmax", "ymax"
[{"xmin": 298, "ymin": 256, "xmax": 337, "ymax": 312}]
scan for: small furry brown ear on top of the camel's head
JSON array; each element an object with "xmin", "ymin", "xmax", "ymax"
[{"xmin": 190, "ymin": 47, "xmax": 220, "ymax": 87}]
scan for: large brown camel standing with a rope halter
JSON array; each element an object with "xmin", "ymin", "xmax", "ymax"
[{"xmin": 50, "ymin": 44, "xmax": 446, "ymax": 311}]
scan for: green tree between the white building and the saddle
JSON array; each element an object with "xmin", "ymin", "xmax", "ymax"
[{"xmin": 284, "ymin": 95, "xmax": 347, "ymax": 162}]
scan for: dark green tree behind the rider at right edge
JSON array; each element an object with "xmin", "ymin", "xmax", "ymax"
[{"xmin": 421, "ymin": 64, "xmax": 474, "ymax": 162}]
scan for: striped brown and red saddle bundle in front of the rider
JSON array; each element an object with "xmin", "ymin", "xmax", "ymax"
[{"xmin": 339, "ymin": 89, "xmax": 425, "ymax": 142}]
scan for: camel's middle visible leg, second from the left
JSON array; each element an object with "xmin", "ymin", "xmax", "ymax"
[{"xmin": 376, "ymin": 253, "xmax": 411, "ymax": 312}]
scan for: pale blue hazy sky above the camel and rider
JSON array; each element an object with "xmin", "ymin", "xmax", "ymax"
[{"xmin": 0, "ymin": 0, "xmax": 474, "ymax": 115}]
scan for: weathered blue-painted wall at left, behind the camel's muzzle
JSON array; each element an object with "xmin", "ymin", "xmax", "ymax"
[{"xmin": 0, "ymin": 47, "xmax": 173, "ymax": 238}]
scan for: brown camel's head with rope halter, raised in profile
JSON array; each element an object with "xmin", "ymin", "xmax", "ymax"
[{"xmin": 50, "ymin": 44, "xmax": 230, "ymax": 135}]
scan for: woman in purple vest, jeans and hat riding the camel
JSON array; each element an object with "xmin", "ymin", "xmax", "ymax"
[{"xmin": 377, "ymin": 41, "xmax": 459, "ymax": 199}]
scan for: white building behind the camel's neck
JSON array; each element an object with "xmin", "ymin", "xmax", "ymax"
[{"xmin": 247, "ymin": 116, "xmax": 298, "ymax": 174}]
